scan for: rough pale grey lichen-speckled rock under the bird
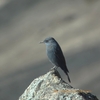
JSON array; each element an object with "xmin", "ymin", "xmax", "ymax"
[{"xmin": 19, "ymin": 70, "xmax": 98, "ymax": 100}]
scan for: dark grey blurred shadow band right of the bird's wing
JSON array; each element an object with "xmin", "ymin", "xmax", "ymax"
[{"xmin": 66, "ymin": 45, "xmax": 100, "ymax": 70}]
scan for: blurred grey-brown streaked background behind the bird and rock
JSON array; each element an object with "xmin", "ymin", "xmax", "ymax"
[{"xmin": 0, "ymin": 0, "xmax": 100, "ymax": 100}]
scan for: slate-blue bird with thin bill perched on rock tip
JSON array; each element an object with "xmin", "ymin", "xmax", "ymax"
[{"xmin": 40, "ymin": 37, "xmax": 71, "ymax": 83}]
